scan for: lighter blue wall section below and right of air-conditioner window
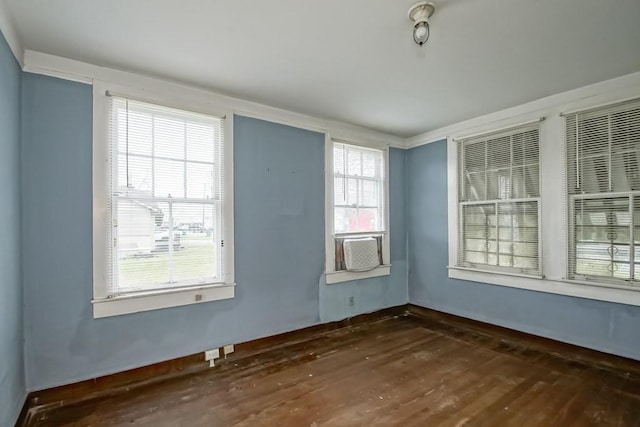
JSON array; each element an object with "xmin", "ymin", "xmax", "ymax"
[{"xmin": 320, "ymin": 148, "xmax": 408, "ymax": 322}]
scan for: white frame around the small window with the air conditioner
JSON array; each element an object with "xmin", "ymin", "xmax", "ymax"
[{"xmin": 325, "ymin": 133, "xmax": 391, "ymax": 284}]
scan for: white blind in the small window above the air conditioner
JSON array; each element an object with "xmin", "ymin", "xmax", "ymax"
[{"xmin": 333, "ymin": 142, "xmax": 385, "ymax": 234}]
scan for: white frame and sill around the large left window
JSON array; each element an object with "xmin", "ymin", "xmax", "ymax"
[{"xmin": 92, "ymin": 81, "xmax": 235, "ymax": 318}]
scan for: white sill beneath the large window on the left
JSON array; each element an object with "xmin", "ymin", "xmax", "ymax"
[{"xmin": 91, "ymin": 283, "xmax": 235, "ymax": 319}]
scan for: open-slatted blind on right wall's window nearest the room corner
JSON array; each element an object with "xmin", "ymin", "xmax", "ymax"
[{"xmin": 458, "ymin": 123, "xmax": 540, "ymax": 274}]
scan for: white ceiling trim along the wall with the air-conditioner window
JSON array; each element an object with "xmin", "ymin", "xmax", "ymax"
[{"xmin": 23, "ymin": 50, "xmax": 405, "ymax": 148}]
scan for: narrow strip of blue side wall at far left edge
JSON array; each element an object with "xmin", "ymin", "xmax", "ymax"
[{"xmin": 0, "ymin": 29, "xmax": 26, "ymax": 426}]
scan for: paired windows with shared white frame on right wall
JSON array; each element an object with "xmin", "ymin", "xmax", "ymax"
[{"xmin": 444, "ymin": 82, "xmax": 640, "ymax": 306}]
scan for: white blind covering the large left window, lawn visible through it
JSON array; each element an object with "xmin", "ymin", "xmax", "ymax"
[{"xmin": 107, "ymin": 96, "xmax": 225, "ymax": 296}]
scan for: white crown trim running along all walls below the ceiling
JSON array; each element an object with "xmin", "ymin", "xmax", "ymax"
[{"xmin": 17, "ymin": 49, "xmax": 640, "ymax": 149}]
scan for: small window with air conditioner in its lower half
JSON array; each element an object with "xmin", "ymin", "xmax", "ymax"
[{"xmin": 327, "ymin": 141, "xmax": 389, "ymax": 283}]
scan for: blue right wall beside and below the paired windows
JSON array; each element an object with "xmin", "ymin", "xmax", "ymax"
[{"xmin": 407, "ymin": 141, "xmax": 640, "ymax": 360}]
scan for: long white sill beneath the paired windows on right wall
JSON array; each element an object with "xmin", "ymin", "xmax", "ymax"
[{"xmin": 448, "ymin": 267, "xmax": 640, "ymax": 306}]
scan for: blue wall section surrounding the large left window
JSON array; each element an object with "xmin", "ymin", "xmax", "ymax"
[{"xmin": 22, "ymin": 78, "xmax": 406, "ymax": 390}]
